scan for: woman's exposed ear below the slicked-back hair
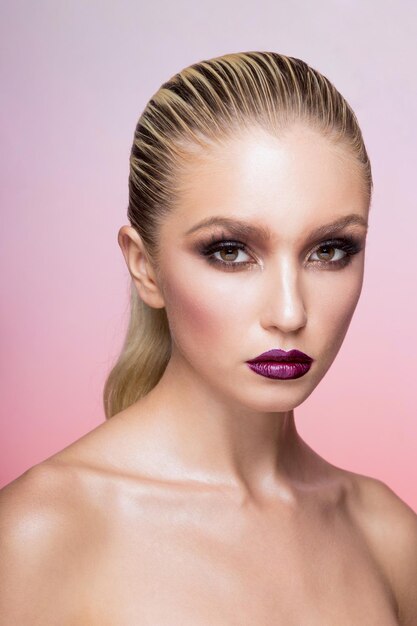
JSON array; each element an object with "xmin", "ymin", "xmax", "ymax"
[{"xmin": 117, "ymin": 226, "xmax": 165, "ymax": 309}]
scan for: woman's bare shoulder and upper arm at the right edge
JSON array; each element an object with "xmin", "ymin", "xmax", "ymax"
[{"xmin": 344, "ymin": 474, "xmax": 417, "ymax": 626}]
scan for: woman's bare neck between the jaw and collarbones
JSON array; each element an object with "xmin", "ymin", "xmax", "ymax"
[{"xmin": 130, "ymin": 358, "xmax": 312, "ymax": 501}]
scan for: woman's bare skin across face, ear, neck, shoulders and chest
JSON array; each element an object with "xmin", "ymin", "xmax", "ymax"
[{"xmin": 0, "ymin": 125, "xmax": 417, "ymax": 626}]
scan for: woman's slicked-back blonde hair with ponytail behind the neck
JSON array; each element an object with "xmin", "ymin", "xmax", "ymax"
[{"xmin": 103, "ymin": 52, "xmax": 373, "ymax": 419}]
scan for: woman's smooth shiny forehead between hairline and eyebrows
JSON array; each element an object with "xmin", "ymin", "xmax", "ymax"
[{"xmin": 172, "ymin": 125, "xmax": 368, "ymax": 237}]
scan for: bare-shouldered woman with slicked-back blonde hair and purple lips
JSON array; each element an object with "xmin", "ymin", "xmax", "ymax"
[{"xmin": 0, "ymin": 52, "xmax": 417, "ymax": 626}]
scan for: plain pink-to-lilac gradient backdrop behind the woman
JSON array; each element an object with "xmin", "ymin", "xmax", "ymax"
[{"xmin": 0, "ymin": 0, "xmax": 417, "ymax": 510}]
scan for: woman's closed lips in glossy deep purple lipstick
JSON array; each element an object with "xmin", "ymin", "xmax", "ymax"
[{"xmin": 246, "ymin": 350, "xmax": 314, "ymax": 380}]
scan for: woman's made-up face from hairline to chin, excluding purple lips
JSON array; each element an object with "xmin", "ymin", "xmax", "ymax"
[{"xmin": 154, "ymin": 124, "xmax": 368, "ymax": 411}]
